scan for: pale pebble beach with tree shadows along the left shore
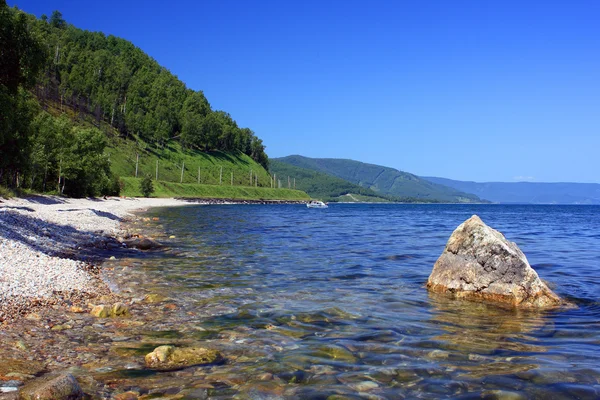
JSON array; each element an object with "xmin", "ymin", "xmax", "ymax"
[{"xmin": 0, "ymin": 196, "xmax": 190, "ymax": 322}]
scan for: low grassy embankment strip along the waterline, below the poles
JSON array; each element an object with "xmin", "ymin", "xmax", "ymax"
[{"xmin": 121, "ymin": 177, "xmax": 310, "ymax": 200}]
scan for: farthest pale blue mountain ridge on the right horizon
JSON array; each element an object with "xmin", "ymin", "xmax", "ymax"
[{"xmin": 422, "ymin": 177, "xmax": 600, "ymax": 204}]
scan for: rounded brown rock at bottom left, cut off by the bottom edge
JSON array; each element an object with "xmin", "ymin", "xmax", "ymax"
[{"xmin": 19, "ymin": 373, "xmax": 83, "ymax": 400}]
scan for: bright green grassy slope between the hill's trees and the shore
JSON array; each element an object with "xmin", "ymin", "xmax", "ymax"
[{"xmin": 38, "ymin": 102, "xmax": 309, "ymax": 200}]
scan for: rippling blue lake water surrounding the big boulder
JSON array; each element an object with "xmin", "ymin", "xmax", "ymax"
[{"xmin": 105, "ymin": 204, "xmax": 600, "ymax": 399}]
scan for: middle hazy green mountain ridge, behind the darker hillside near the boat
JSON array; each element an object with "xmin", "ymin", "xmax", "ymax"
[{"xmin": 275, "ymin": 155, "xmax": 482, "ymax": 203}]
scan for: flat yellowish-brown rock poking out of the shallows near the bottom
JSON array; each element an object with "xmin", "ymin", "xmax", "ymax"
[{"xmin": 145, "ymin": 346, "xmax": 223, "ymax": 370}]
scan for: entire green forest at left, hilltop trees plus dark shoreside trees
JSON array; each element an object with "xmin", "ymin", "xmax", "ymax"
[{"xmin": 0, "ymin": 0, "xmax": 271, "ymax": 196}]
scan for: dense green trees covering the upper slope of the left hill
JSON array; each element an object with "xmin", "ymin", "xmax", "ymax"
[{"xmin": 28, "ymin": 12, "xmax": 268, "ymax": 168}]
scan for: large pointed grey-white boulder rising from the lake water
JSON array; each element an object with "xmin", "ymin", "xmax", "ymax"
[{"xmin": 427, "ymin": 215, "xmax": 564, "ymax": 308}]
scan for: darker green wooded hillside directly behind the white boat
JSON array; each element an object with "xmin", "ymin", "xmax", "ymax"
[{"xmin": 270, "ymin": 159, "xmax": 394, "ymax": 202}]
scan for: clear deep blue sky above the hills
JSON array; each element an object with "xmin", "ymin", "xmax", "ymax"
[{"xmin": 8, "ymin": 0, "xmax": 600, "ymax": 182}]
